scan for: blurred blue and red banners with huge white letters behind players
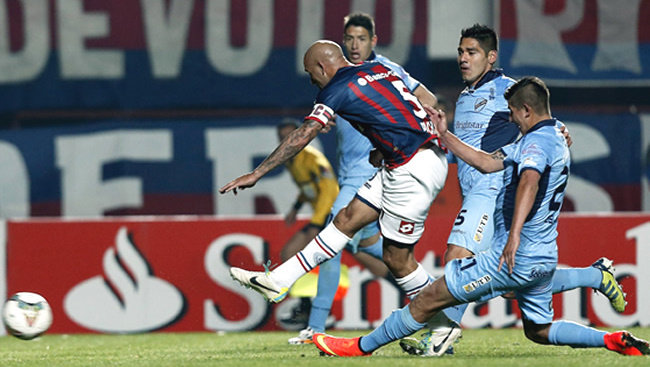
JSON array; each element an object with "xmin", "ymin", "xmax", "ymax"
[{"xmin": 0, "ymin": 0, "xmax": 650, "ymax": 217}]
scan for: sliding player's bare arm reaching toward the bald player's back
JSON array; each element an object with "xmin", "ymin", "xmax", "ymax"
[{"xmin": 424, "ymin": 105, "xmax": 505, "ymax": 173}]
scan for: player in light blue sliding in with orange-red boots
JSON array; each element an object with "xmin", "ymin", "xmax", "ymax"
[{"xmin": 314, "ymin": 77, "xmax": 650, "ymax": 357}]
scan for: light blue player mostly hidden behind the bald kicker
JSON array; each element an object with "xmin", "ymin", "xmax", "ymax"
[{"xmin": 282, "ymin": 13, "xmax": 436, "ymax": 344}]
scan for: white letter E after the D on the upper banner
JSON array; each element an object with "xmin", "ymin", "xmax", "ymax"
[{"xmin": 56, "ymin": 0, "xmax": 124, "ymax": 79}]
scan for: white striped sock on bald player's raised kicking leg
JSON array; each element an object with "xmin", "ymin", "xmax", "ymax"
[{"xmin": 271, "ymin": 223, "xmax": 352, "ymax": 287}]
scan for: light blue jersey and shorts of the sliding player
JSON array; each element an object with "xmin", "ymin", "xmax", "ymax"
[{"xmin": 445, "ymin": 119, "xmax": 570, "ymax": 324}]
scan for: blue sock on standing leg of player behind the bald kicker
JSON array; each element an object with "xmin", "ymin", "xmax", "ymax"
[{"xmin": 308, "ymin": 252, "xmax": 341, "ymax": 333}]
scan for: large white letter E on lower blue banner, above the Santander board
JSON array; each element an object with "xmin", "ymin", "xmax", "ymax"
[{"xmin": 55, "ymin": 129, "xmax": 173, "ymax": 216}]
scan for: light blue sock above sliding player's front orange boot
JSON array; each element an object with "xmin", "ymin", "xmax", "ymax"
[{"xmin": 359, "ymin": 305, "xmax": 426, "ymax": 353}]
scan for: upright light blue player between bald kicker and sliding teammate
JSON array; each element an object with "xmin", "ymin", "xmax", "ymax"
[{"xmin": 400, "ymin": 24, "xmax": 626, "ymax": 356}]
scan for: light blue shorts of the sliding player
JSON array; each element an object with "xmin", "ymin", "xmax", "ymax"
[{"xmin": 445, "ymin": 242, "xmax": 557, "ymax": 324}]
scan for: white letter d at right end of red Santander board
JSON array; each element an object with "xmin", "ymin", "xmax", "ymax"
[{"xmin": 591, "ymin": 222, "xmax": 650, "ymax": 327}]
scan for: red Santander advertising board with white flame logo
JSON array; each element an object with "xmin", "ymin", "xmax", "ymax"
[{"xmin": 5, "ymin": 213, "xmax": 650, "ymax": 333}]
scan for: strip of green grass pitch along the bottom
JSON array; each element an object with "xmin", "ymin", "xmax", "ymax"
[{"xmin": 0, "ymin": 328, "xmax": 650, "ymax": 367}]
